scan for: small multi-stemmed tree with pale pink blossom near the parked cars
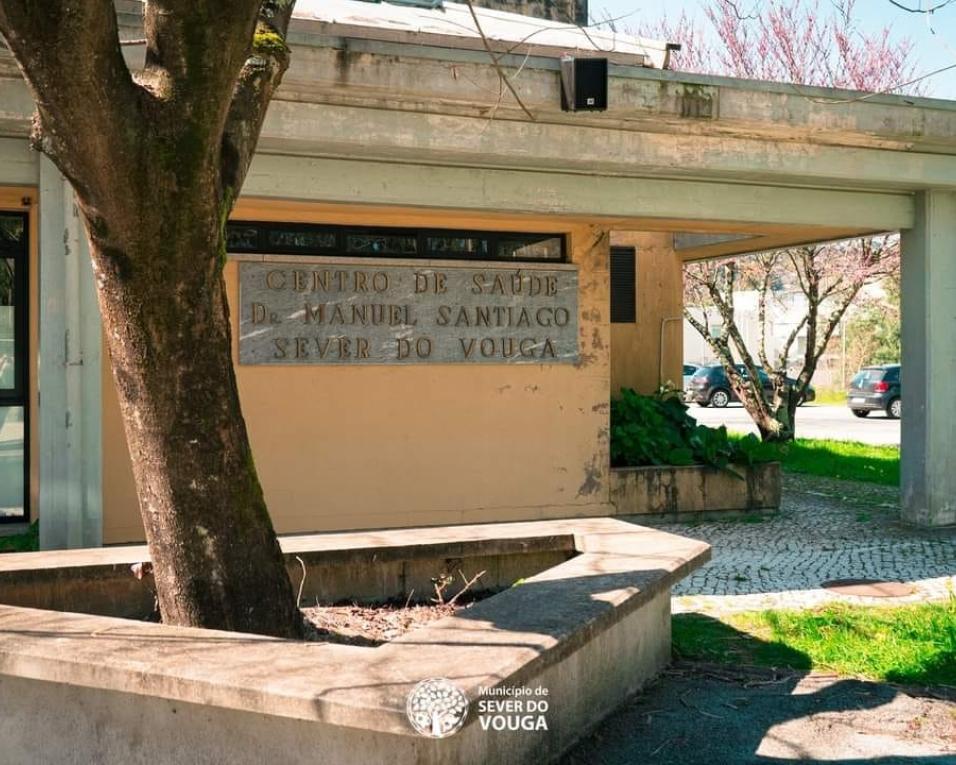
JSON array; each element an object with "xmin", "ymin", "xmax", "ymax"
[{"xmin": 684, "ymin": 235, "xmax": 900, "ymax": 441}]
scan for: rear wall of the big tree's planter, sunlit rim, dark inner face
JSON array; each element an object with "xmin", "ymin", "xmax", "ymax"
[{"xmin": 0, "ymin": 523, "xmax": 574, "ymax": 619}]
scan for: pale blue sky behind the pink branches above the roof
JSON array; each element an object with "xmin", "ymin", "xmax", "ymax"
[{"xmin": 589, "ymin": 0, "xmax": 956, "ymax": 100}]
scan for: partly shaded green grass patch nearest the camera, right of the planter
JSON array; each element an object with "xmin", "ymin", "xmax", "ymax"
[{"xmin": 673, "ymin": 597, "xmax": 956, "ymax": 686}]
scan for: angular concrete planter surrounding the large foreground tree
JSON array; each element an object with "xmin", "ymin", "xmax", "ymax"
[{"xmin": 0, "ymin": 518, "xmax": 709, "ymax": 763}]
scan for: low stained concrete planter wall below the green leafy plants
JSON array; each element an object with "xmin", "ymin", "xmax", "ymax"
[{"xmin": 611, "ymin": 462, "xmax": 781, "ymax": 522}]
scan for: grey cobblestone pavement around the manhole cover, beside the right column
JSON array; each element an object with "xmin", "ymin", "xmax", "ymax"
[{"xmin": 662, "ymin": 475, "xmax": 956, "ymax": 614}]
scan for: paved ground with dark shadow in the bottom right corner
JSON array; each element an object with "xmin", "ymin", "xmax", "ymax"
[{"xmin": 562, "ymin": 662, "xmax": 956, "ymax": 765}]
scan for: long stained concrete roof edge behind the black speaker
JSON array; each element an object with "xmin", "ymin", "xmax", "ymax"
[{"xmin": 0, "ymin": 41, "xmax": 956, "ymax": 191}]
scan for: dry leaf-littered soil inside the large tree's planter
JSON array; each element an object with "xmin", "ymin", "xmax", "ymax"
[{"xmin": 302, "ymin": 592, "xmax": 494, "ymax": 647}]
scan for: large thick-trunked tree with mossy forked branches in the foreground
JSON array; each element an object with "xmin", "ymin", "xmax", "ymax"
[{"xmin": 0, "ymin": 0, "xmax": 300, "ymax": 636}]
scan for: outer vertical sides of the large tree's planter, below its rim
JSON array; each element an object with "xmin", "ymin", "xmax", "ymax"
[{"xmin": 0, "ymin": 591, "xmax": 670, "ymax": 765}]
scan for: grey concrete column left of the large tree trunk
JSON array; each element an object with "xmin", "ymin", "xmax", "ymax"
[{"xmin": 39, "ymin": 157, "xmax": 103, "ymax": 550}]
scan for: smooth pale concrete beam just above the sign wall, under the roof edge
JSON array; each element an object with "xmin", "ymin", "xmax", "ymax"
[{"xmin": 243, "ymin": 154, "xmax": 913, "ymax": 230}]
